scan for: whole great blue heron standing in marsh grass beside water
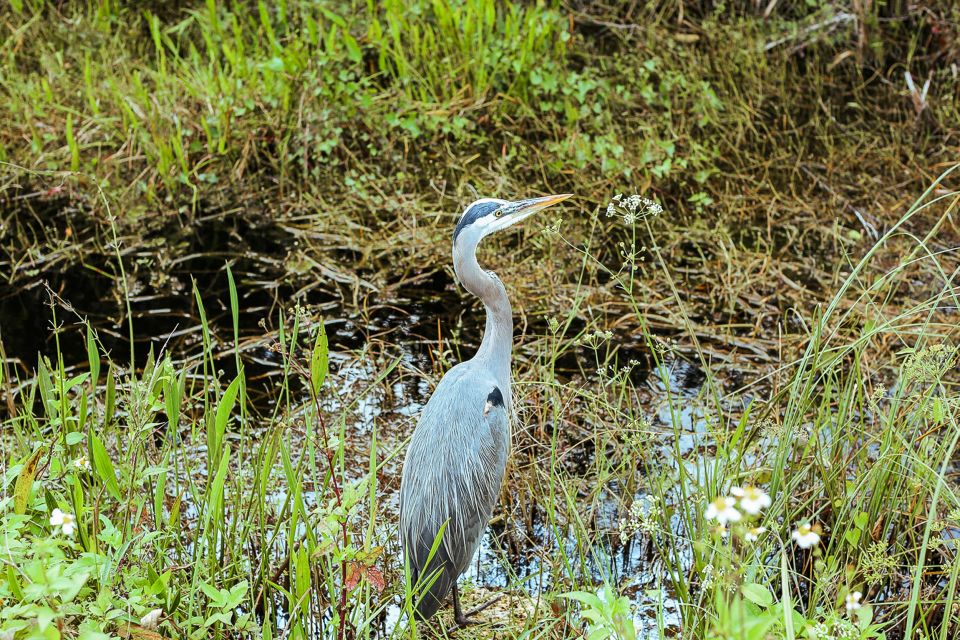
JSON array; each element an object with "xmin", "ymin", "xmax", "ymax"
[{"xmin": 400, "ymin": 194, "xmax": 570, "ymax": 625}]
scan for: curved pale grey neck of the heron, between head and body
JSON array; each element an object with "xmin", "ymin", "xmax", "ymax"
[{"xmin": 453, "ymin": 246, "xmax": 513, "ymax": 394}]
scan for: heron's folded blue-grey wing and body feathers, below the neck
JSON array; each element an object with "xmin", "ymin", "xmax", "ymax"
[{"xmin": 400, "ymin": 369, "xmax": 510, "ymax": 618}]
